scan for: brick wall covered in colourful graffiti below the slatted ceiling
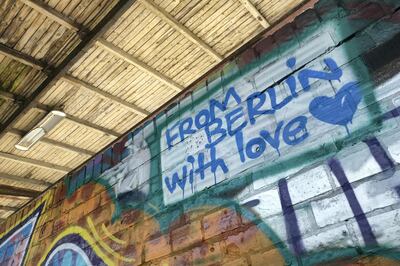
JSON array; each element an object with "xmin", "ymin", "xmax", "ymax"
[{"xmin": 0, "ymin": 0, "xmax": 400, "ymax": 265}]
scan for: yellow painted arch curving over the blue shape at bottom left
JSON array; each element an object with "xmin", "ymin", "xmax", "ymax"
[{"xmin": 39, "ymin": 226, "xmax": 115, "ymax": 266}]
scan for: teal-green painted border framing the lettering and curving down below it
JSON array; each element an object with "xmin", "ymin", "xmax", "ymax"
[{"xmin": 68, "ymin": 0, "xmax": 400, "ymax": 265}]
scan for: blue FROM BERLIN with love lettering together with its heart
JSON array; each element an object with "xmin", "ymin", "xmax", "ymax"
[{"xmin": 164, "ymin": 57, "xmax": 362, "ymax": 196}]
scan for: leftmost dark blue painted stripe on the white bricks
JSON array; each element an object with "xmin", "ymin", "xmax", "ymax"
[{"xmin": 278, "ymin": 179, "xmax": 305, "ymax": 256}]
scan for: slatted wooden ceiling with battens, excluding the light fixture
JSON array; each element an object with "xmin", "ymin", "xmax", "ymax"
[{"xmin": 0, "ymin": 0, "xmax": 303, "ymax": 219}]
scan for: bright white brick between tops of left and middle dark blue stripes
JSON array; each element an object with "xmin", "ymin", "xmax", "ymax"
[{"xmin": 288, "ymin": 165, "xmax": 332, "ymax": 205}]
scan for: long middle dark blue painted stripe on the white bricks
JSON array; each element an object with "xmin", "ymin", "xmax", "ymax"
[{"xmin": 328, "ymin": 159, "xmax": 378, "ymax": 246}]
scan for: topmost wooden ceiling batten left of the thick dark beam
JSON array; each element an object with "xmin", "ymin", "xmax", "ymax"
[{"xmin": 20, "ymin": 0, "xmax": 80, "ymax": 32}]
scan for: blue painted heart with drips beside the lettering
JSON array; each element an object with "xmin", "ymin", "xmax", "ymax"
[{"xmin": 309, "ymin": 82, "xmax": 362, "ymax": 135}]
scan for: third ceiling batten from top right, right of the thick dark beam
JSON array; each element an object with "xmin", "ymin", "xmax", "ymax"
[{"xmin": 97, "ymin": 39, "xmax": 183, "ymax": 92}]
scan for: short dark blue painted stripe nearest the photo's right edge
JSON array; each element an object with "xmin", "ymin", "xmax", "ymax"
[{"xmin": 364, "ymin": 137, "xmax": 400, "ymax": 196}]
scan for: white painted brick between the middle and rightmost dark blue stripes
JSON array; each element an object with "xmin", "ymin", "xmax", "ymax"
[{"xmin": 332, "ymin": 144, "xmax": 382, "ymax": 187}]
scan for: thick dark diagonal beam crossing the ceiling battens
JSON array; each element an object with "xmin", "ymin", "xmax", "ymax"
[{"xmin": 0, "ymin": 0, "xmax": 141, "ymax": 141}]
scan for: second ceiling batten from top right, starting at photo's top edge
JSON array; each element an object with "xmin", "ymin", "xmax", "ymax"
[{"xmin": 139, "ymin": 0, "xmax": 224, "ymax": 62}]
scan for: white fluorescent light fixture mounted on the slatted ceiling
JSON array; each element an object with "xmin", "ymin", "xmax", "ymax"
[{"xmin": 15, "ymin": 110, "xmax": 66, "ymax": 151}]
